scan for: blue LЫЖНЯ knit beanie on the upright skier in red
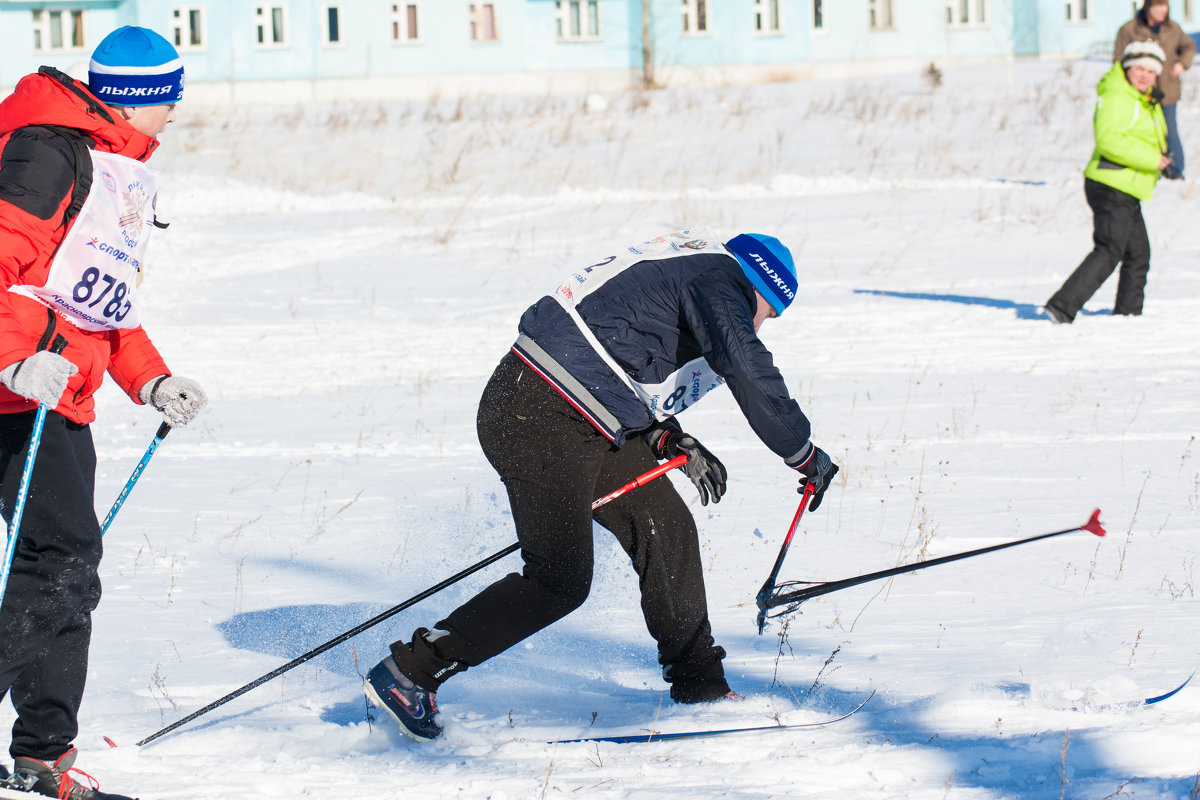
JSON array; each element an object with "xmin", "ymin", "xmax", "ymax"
[{"xmin": 88, "ymin": 25, "xmax": 184, "ymax": 106}]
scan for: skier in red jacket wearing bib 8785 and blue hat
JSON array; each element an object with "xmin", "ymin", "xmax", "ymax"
[{"xmin": 0, "ymin": 26, "xmax": 206, "ymax": 800}]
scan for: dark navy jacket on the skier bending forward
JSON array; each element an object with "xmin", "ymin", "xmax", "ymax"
[{"xmin": 512, "ymin": 251, "xmax": 811, "ymax": 467}]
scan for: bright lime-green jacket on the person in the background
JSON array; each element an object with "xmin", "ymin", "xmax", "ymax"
[{"xmin": 1084, "ymin": 64, "xmax": 1166, "ymax": 200}]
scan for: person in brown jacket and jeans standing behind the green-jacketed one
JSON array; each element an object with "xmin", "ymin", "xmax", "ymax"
[{"xmin": 1112, "ymin": 0, "xmax": 1196, "ymax": 180}]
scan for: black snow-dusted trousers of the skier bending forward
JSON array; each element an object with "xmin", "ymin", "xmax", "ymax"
[{"xmin": 392, "ymin": 353, "xmax": 728, "ymax": 702}]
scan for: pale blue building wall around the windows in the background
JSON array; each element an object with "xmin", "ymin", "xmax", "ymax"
[{"xmin": 0, "ymin": 0, "xmax": 1200, "ymax": 94}]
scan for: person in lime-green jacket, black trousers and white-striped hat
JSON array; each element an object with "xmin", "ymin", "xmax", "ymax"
[{"xmin": 1045, "ymin": 42, "xmax": 1171, "ymax": 323}]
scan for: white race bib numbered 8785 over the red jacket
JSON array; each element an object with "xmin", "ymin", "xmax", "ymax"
[{"xmin": 10, "ymin": 151, "xmax": 158, "ymax": 331}]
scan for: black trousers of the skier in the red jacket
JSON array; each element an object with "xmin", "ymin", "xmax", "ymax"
[{"xmin": 0, "ymin": 411, "xmax": 102, "ymax": 763}]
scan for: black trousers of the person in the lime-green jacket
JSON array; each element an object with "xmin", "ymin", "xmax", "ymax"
[{"xmin": 1046, "ymin": 178, "xmax": 1150, "ymax": 319}]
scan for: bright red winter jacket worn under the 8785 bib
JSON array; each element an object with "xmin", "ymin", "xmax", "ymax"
[{"xmin": 0, "ymin": 67, "xmax": 170, "ymax": 423}]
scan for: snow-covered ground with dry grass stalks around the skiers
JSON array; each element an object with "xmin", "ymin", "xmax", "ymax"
[{"xmin": 0, "ymin": 61, "xmax": 1200, "ymax": 800}]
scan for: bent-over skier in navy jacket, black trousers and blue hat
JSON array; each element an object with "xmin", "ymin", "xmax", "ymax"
[{"xmin": 365, "ymin": 229, "xmax": 838, "ymax": 740}]
